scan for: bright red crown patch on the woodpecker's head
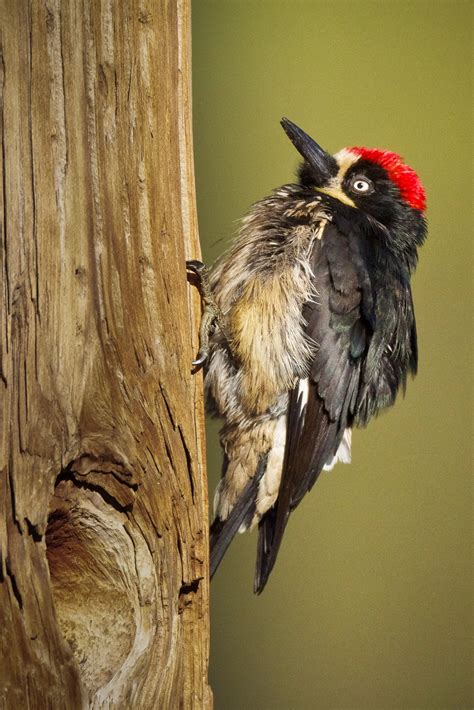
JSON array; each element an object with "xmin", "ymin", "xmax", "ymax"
[{"xmin": 349, "ymin": 147, "xmax": 426, "ymax": 211}]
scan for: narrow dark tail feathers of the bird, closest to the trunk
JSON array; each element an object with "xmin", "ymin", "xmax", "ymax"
[{"xmin": 210, "ymin": 455, "xmax": 267, "ymax": 579}]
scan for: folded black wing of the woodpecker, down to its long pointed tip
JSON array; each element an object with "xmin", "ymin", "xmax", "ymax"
[{"xmin": 254, "ymin": 224, "xmax": 375, "ymax": 593}]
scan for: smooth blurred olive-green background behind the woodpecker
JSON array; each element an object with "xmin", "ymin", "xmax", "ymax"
[{"xmin": 192, "ymin": 0, "xmax": 474, "ymax": 710}]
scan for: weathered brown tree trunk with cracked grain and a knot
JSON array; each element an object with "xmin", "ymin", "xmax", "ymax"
[{"xmin": 0, "ymin": 0, "xmax": 212, "ymax": 710}]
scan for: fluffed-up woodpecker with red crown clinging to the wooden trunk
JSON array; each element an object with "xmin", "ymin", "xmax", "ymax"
[{"xmin": 188, "ymin": 118, "xmax": 427, "ymax": 594}]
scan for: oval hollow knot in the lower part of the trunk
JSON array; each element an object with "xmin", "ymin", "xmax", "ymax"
[{"xmin": 46, "ymin": 454, "xmax": 158, "ymax": 702}]
